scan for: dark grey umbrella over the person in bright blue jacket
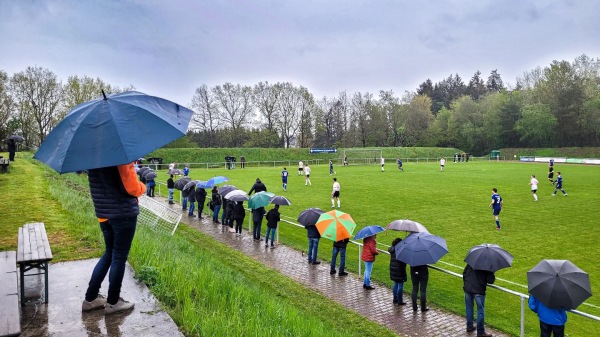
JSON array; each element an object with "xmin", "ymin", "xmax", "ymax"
[{"xmin": 527, "ymin": 260, "xmax": 592, "ymax": 309}]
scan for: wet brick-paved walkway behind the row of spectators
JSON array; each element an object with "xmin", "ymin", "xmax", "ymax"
[{"xmin": 166, "ymin": 198, "xmax": 506, "ymax": 336}]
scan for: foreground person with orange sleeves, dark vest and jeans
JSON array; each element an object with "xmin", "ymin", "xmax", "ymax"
[{"xmin": 81, "ymin": 163, "xmax": 146, "ymax": 314}]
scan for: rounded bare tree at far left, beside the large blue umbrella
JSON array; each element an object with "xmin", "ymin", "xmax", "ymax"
[{"xmin": 10, "ymin": 67, "xmax": 62, "ymax": 145}]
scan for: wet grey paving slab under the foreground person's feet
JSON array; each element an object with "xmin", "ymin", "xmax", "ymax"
[{"xmin": 21, "ymin": 259, "xmax": 183, "ymax": 337}]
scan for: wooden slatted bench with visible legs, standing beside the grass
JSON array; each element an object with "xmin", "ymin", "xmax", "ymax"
[{"xmin": 17, "ymin": 222, "xmax": 52, "ymax": 306}]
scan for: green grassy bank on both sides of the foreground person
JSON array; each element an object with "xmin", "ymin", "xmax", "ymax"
[{"xmin": 0, "ymin": 154, "xmax": 394, "ymax": 336}]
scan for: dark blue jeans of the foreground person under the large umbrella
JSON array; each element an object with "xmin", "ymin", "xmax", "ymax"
[{"xmin": 85, "ymin": 216, "xmax": 137, "ymax": 304}]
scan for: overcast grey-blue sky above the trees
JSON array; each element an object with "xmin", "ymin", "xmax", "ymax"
[{"xmin": 0, "ymin": 0, "xmax": 600, "ymax": 105}]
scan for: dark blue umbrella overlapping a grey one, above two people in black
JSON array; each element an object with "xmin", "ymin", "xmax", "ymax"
[{"xmin": 396, "ymin": 233, "xmax": 448, "ymax": 266}]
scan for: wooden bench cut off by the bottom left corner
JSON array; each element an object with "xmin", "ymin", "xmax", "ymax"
[{"xmin": 0, "ymin": 251, "xmax": 21, "ymax": 336}]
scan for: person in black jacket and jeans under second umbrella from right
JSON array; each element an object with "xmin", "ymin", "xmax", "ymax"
[{"xmin": 463, "ymin": 264, "xmax": 496, "ymax": 337}]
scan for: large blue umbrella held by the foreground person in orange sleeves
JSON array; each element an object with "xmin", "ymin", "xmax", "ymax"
[{"xmin": 34, "ymin": 91, "xmax": 193, "ymax": 173}]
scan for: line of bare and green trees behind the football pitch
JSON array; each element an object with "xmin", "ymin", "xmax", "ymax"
[{"xmin": 0, "ymin": 55, "xmax": 600, "ymax": 154}]
